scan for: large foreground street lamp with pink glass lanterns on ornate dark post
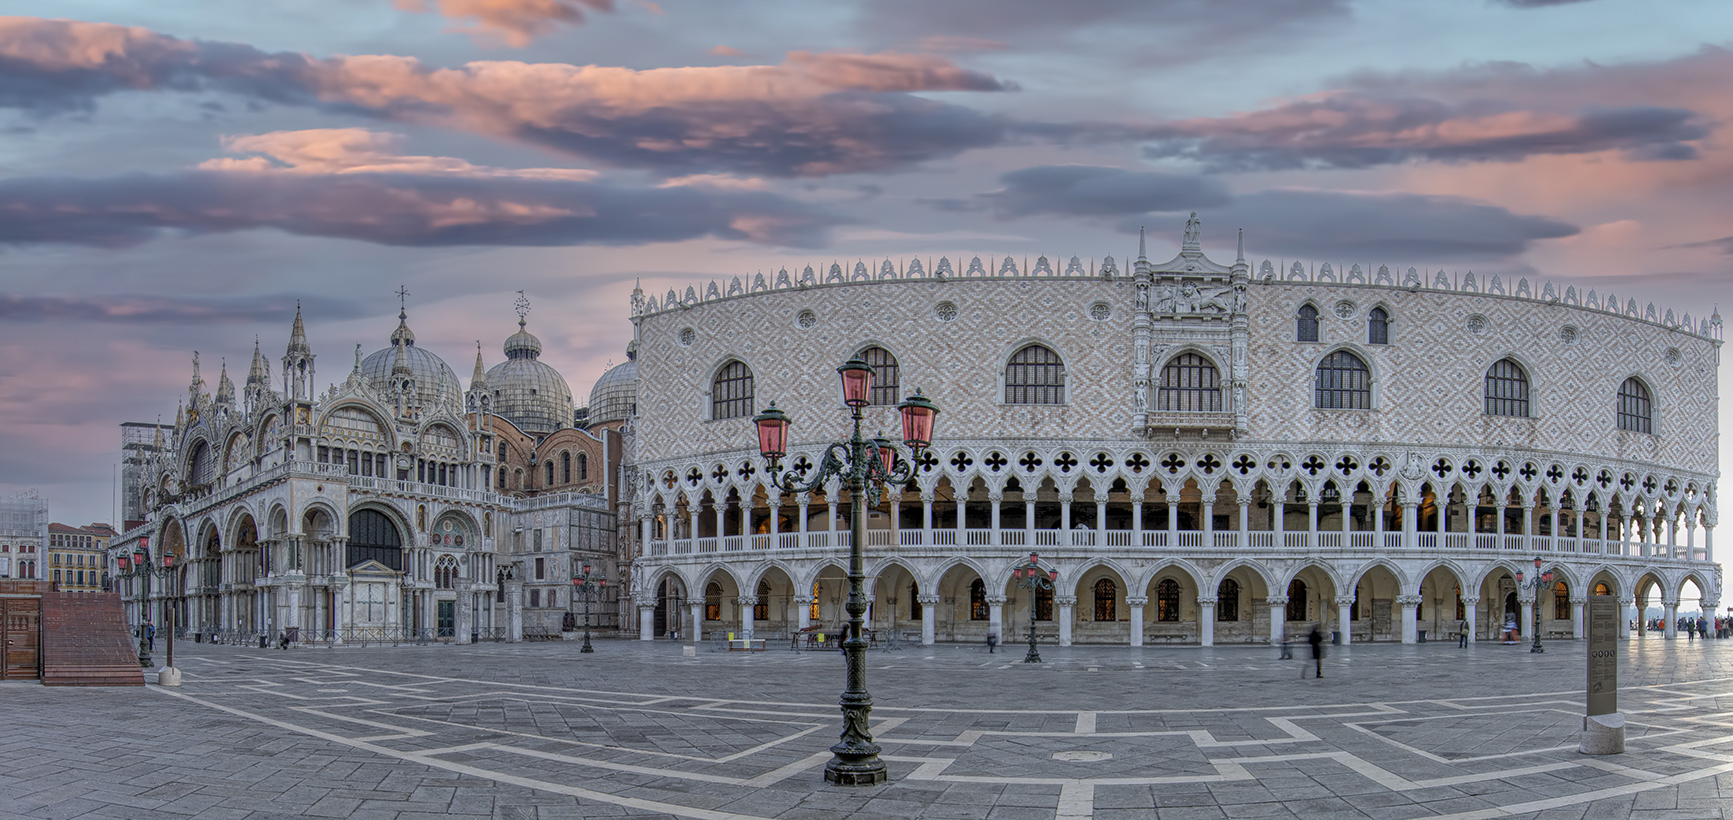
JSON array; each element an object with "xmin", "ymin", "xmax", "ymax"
[{"xmin": 752, "ymin": 359, "xmax": 939, "ymax": 785}]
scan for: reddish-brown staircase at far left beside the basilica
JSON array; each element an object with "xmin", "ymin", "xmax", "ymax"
[{"xmin": 42, "ymin": 593, "xmax": 144, "ymax": 687}]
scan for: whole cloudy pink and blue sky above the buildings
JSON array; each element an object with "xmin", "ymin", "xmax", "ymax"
[{"xmin": 0, "ymin": 0, "xmax": 1733, "ymax": 599}]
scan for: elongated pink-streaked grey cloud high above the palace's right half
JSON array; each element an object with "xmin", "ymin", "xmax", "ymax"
[{"xmin": 1144, "ymin": 92, "xmax": 1709, "ymax": 172}]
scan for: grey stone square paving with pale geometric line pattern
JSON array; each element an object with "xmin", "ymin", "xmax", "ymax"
[{"xmin": 0, "ymin": 638, "xmax": 1733, "ymax": 820}]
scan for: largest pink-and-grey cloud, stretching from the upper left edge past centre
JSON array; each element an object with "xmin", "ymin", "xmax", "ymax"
[{"xmin": 0, "ymin": 17, "xmax": 1010, "ymax": 177}]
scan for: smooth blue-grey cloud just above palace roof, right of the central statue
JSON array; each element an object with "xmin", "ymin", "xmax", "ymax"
[{"xmin": 1192, "ymin": 189, "xmax": 1579, "ymax": 264}]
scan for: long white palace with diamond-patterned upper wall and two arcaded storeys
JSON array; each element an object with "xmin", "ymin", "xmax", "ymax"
[{"xmin": 627, "ymin": 215, "xmax": 1721, "ymax": 645}]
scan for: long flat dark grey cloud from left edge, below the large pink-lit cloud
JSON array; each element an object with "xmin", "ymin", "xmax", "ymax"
[{"xmin": 0, "ymin": 170, "xmax": 837, "ymax": 246}]
